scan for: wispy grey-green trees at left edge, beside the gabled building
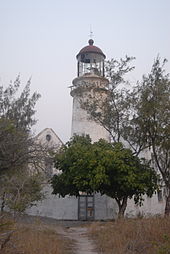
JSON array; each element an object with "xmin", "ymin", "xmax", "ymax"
[{"xmin": 0, "ymin": 76, "xmax": 47, "ymax": 212}]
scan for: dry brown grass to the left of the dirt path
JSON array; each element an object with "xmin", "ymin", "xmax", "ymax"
[{"xmin": 0, "ymin": 214, "xmax": 68, "ymax": 254}]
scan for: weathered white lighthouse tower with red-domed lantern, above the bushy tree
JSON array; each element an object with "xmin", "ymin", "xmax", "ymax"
[{"xmin": 70, "ymin": 39, "xmax": 110, "ymax": 142}]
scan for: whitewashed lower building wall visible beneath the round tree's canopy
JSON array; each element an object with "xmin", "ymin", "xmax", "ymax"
[{"xmin": 26, "ymin": 185, "xmax": 165, "ymax": 220}]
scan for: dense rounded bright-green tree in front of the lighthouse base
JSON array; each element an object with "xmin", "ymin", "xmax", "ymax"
[{"xmin": 52, "ymin": 136, "xmax": 157, "ymax": 216}]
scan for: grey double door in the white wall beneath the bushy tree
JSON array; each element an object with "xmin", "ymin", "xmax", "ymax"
[{"xmin": 78, "ymin": 195, "xmax": 94, "ymax": 220}]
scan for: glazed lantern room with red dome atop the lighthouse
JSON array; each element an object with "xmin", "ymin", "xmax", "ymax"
[{"xmin": 77, "ymin": 39, "xmax": 106, "ymax": 77}]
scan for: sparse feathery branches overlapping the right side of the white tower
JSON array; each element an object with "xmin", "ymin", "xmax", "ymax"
[{"xmin": 80, "ymin": 56, "xmax": 134, "ymax": 142}]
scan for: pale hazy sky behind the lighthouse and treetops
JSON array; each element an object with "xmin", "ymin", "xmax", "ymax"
[{"xmin": 0, "ymin": 0, "xmax": 170, "ymax": 142}]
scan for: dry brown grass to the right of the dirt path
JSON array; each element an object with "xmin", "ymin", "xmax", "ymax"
[{"xmin": 90, "ymin": 218, "xmax": 170, "ymax": 254}]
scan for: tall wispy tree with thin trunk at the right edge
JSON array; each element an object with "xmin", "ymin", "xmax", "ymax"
[{"xmin": 129, "ymin": 57, "xmax": 170, "ymax": 215}]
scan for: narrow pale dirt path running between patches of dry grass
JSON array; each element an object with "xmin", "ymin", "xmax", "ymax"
[{"xmin": 62, "ymin": 227, "xmax": 98, "ymax": 254}]
